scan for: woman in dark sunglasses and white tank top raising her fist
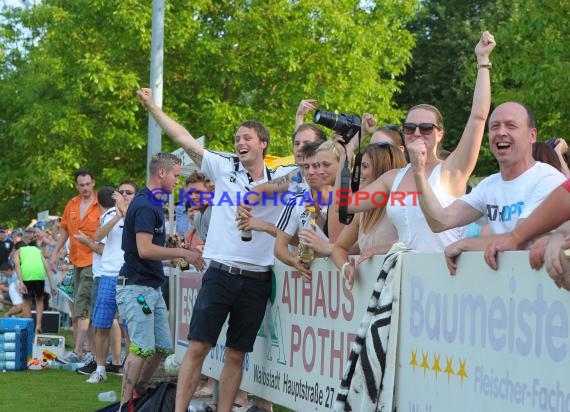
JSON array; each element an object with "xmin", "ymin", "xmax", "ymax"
[{"xmin": 349, "ymin": 32, "xmax": 495, "ymax": 252}]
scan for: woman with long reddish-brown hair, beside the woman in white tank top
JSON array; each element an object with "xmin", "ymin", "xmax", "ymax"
[{"xmin": 332, "ymin": 142, "xmax": 407, "ymax": 287}]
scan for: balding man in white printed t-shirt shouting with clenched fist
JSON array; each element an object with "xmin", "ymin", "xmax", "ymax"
[{"xmin": 407, "ymin": 102, "xmax": 565, "ymax": 275}]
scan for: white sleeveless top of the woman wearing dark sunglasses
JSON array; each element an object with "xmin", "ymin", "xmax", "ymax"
[{"xmin": 386, "ymin": 163, "xmax": 465, "ymax": 252}]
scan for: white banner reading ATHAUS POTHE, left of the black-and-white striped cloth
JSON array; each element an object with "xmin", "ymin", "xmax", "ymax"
[{"xmin": 176, "ymin": 257, "xmax": 382, "ymax": 411}]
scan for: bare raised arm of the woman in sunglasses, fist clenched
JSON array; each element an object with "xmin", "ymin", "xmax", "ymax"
[{"xmin": 441, "ymin": 31, "xmax": 495, "ymax": 196}]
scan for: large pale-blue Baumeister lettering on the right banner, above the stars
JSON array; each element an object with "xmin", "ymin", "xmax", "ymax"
[{"xmin": 410, "ymin": 276, "xmax": 570, "ymax": 362}]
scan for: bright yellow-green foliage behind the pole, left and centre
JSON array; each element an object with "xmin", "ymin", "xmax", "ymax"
[{"xmin": 0, "ymin": 0, "xmax": 417, "ymax": 224}]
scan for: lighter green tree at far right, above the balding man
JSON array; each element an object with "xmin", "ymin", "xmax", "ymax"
[{"xmin": 495, "ymin": 0, "xmax": 570, "ymax": 140}]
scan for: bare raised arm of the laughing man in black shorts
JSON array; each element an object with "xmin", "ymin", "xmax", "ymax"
[{"xmin": 137, "ymin": 88, "xmax": 204, "ymax": 167}]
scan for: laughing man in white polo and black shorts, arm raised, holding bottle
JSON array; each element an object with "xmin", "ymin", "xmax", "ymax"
[{"xmin": 137, "ymin": 89, "xmax": 296, "ymax": 412}]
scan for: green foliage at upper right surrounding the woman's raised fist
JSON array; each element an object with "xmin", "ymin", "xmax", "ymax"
[{"xmin": 397, "ymin": 0, "xmax": 570, "ymax": 177}]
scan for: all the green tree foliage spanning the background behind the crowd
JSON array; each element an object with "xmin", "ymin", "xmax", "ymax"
[{"xmin": 0, "ymin": 0, "xmax": 570, "ymax": 222}]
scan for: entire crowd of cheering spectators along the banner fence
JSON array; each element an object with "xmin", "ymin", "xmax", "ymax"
[{"xmin": 0, "ymin": 28, "xmax": 570, "ymax": 412}]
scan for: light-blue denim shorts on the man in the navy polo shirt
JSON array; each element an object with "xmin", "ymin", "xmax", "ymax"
[{"xmin": 117, "ymin": 285, "xmax": 173, "ymax": 357}]
